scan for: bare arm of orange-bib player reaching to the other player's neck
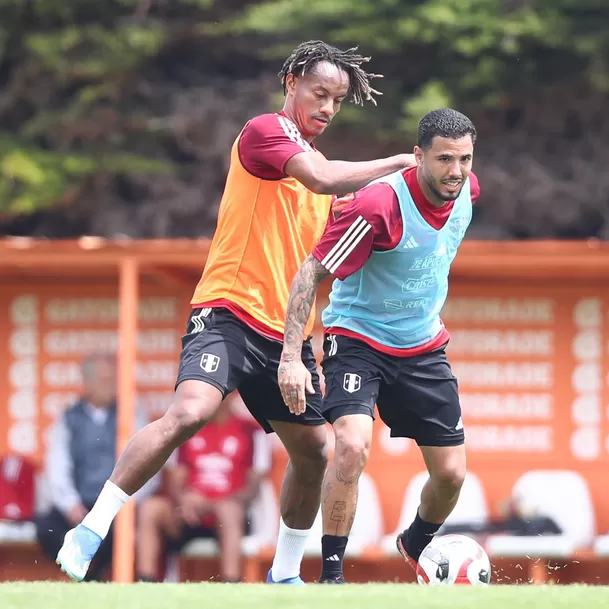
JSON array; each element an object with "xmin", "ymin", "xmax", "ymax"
[{"xmin": 284, "ymin": 152, "xmax": 416, "ymax": 195}]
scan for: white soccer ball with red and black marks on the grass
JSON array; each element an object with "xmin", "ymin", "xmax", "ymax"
[{"xmin": 417, "ymin": 535, "xmax": 491, "ymax": 586}]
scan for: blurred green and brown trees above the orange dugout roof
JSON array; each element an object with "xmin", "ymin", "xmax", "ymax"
[{"xmin": 0, "ymin": 0, "xmax": 609, "ymax": 238}]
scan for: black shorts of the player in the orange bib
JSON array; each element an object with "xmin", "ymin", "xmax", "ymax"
[{"xmin": 176, "ymin": 308, "xmax": 326, "ymax": 433}]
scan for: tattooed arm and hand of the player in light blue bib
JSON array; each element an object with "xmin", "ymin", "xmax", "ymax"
[{"xmin": 277, "ymin": 256, "xmax": 330, "ymax": 414}]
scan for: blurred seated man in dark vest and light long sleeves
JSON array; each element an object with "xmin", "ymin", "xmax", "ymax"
[{"xmin": 36, "ymin": 354, "xmax": 159, "ymax": 580}]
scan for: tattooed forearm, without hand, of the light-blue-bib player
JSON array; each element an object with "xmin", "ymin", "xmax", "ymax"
[{"xmin": 283, "ymin": 256, "xmax": 330, "ymax": 358}]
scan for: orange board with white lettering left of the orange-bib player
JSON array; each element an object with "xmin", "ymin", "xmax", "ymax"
[{"xmin": 0, "ymin": 284, "xmax": 188, "ymax": 461}]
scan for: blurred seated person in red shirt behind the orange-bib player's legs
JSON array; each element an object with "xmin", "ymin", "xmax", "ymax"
[{"xmin": 136, "ymin": 392, "xmax": 271, "ymax": 582}]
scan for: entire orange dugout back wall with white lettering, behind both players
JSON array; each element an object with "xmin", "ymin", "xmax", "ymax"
[{"xmin": 0, "ymin": 268, "xmax": 609, "ymax": 533}]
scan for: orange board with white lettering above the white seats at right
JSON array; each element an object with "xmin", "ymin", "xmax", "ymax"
[{"xmin": 443, "ymin": 284, "xmax": 609, "ymax": 467}]
